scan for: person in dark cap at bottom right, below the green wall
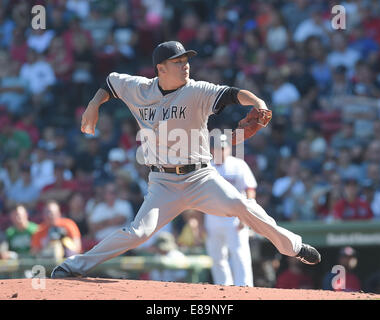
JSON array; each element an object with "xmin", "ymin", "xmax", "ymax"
[{"xmin": 322, "ymin": 247, "xmax": 361, "ymax": 292}]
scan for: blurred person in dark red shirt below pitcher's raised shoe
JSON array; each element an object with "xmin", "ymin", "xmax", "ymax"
[{"xmin": 276, "ymin": 257, "xmax": 314, "ymax": 289}]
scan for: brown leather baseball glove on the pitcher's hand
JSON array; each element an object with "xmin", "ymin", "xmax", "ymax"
[{"xmin": 232, "ymin": 107, "xmax": 272, "ymax": 145}]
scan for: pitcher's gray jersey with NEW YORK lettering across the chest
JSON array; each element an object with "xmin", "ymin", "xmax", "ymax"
[{"xmin": 106, "ymin": 72, "xmax": 228, "ymax": 166}]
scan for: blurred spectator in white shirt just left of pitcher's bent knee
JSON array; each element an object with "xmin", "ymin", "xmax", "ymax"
[{"xmin": 88, "ymin": 183, "xmax": 134, "ymax": 241}]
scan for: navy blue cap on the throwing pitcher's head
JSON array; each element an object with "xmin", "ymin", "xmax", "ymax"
[{"xmin": 153, "ymin": 41, "xmax": 197, "ymax": 74}]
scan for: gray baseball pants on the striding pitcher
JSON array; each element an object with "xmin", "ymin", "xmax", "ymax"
[{"xmin": 61, "ymin": 166, "xmax": 302, "ymax": 275}]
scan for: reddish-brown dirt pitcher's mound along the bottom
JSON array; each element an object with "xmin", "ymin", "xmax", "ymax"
[{"xmin": 0, "ymin": 278, "xmax": 380, "ymax": 300}]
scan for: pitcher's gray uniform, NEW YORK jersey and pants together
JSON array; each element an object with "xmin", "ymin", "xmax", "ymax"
[{"xmin": 61, "ymin": 73, "xmax": 302, "ymax": 275}]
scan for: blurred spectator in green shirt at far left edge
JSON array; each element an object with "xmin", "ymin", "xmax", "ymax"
[{"xmin": 6, "ymin": 205, "xmax": 38, "ymax": 258}]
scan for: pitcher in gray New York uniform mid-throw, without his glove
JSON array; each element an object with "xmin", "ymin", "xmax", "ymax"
[{"xmin": 51, "ymin": 41, "xmax": 320, "ymax": 278}]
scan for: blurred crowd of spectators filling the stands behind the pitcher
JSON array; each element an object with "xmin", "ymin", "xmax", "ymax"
[{"xmin": 0, "ymin": 0, "xmax": 380, "ymax": 290}]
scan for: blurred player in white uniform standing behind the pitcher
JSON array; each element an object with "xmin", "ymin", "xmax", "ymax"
[{"xmin": 205, "ymin": 134, "xmax": 257, "ymax": 287}]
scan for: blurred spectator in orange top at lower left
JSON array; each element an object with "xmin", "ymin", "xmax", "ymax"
[{"xmin": 31, "ymin": 201, "xmax": 82, "ymax": 259}]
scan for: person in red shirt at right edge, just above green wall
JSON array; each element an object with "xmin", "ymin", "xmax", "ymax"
[{"xmin": 333, "ymin": 179, "xmax": 373, "ymax": 220}]
